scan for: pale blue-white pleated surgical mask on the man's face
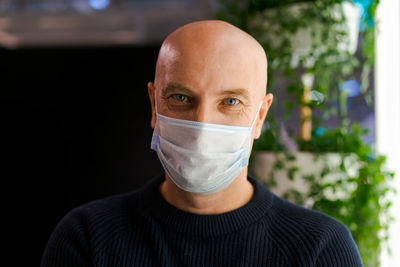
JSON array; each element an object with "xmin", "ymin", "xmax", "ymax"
[{"xmin": 151, "ymin": 98, "xmax": 261, "ymax": 194}]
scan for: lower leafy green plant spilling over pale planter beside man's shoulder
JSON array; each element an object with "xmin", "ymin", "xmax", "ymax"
[{"xmin": 302, "ymin": 124, "xmax": 394, "ymax": 266}]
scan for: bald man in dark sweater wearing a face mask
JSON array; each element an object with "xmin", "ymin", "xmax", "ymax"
[{"xmin": 41, "ymin": 21, "xmax": 362, "ymax": 267}]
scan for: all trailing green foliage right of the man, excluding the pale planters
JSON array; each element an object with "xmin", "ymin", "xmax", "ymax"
[{"xmin": 216, "ymin": 0, "xmax": 393, "ymax": 266}]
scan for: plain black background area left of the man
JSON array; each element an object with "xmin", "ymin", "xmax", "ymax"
[{"xmin": 0, "ymin": 44, "xmax": 162, "ymax": 266}]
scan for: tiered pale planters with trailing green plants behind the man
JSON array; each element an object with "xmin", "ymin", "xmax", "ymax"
[{"xmin": 217, "ymin": 0, "xmax": 393, "ymax": 266}]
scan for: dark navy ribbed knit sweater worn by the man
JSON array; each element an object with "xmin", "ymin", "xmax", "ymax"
[{"xmin": 41, "ymin": 176, "xmax": 362, "ymax": 267}]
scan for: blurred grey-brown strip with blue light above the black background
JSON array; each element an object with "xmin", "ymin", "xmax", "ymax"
[{"xmin": 0, "ymin": 0, "xmax": 216, "ymax": 48}]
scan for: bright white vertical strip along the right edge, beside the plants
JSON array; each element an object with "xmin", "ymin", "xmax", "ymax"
[{"xmin": 375, "ymin": 0, "xmax": 400, "ymax": 267}]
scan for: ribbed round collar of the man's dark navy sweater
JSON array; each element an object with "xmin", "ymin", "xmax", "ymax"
[{"xmin": 140, "ymin": 175, "xmax": 272, "ymax": 236}]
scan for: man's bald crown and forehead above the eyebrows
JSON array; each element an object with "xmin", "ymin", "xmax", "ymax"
[{"xmin": 155, "ymin": 20, "xmax": 267, "ymax": 97}]
